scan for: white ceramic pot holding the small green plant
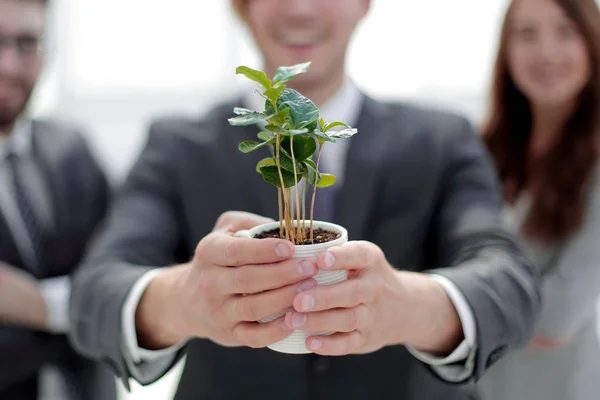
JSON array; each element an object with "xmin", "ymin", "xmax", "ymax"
[{"xmin": 236, "ymin": 221, "xmax": 348, "ymax": 354}]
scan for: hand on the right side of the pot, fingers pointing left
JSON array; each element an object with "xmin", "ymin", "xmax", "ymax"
[{"xmin": 285, "ymin": 242, "xmax": 464, "ymax": 355}]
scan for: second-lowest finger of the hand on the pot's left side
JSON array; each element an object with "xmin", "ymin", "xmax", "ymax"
[{"xmin": 227, "ymin": 279, "xmax": 317, "ymax": 322}]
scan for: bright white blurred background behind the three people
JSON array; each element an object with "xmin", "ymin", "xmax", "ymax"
[{"xmin": 27, "ymin": 0, "xmax": 600, "ymax": 400}]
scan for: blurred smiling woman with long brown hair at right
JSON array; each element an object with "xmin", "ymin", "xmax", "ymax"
[{"xmin": 480, "ymin": 0, "xmax": 600, "ymax": 400}]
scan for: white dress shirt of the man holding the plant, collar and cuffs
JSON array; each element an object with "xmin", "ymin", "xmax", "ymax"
[{"xmin": 122, "ymin": 78, "xmax": 477, "ymax": 382}]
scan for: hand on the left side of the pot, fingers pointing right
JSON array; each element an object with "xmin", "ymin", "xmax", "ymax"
[{"xmin": 136, "ymin": 212, "xmax": 317, "ymax": 348}]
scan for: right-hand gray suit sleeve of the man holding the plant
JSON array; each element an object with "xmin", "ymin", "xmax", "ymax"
[{"xmin": 433, "ymin": 118, "xmax": 541, "ymax": 381}]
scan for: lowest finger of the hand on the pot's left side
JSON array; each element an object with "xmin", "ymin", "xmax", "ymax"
[{"xmin": 233, "ymin": 317, "xmax": 293, "ymax": 348}]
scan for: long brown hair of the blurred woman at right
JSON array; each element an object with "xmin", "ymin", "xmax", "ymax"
[{"xmin": 483, "ymin": 0, "xmax": 600, "ymax": 244}]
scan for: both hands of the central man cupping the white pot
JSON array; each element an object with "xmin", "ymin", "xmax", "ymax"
[{"xmin": 136, "ymin": 212, "xmax": 463, "ymax": 355}]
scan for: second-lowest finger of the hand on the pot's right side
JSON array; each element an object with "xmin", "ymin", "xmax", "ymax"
[{"xmin": 285, "ymin": 305, "xmax": 368, "ymax": 332}]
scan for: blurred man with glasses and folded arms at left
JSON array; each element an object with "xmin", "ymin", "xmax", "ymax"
[{"xmin": 0, "ymin": 0, "xmax": 115, "ymax": 400}]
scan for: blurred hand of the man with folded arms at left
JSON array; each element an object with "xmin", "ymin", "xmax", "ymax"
[{"xmin": 0, "ymin": 262, "xmax": 48, "ymax": 330}]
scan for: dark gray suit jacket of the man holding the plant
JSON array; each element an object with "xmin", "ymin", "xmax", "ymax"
[{"xmin": 72, "ymin": 98, "xmax": 540, "ymax": 400}]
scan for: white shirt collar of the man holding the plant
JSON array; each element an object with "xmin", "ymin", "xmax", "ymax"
[{"xmin": 243, "ymin": 77, "xmax": 364, "ymax": 128}]
